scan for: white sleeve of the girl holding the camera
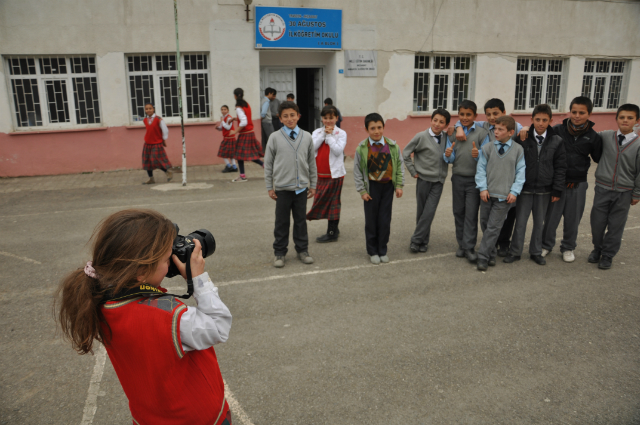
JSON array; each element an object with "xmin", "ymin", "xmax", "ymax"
[{"xmin": 180, "ymin": 272, "xmax": 231, "ymax": 351}]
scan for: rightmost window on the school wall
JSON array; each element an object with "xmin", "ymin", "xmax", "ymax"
[{"xmin": 582, "ymin": 59, "xmax": 626, "ymax": 109}]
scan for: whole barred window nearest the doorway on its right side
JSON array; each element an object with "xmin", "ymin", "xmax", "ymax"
[{"xmin": 413, "ymin": 54, "xmax": 474, "ymax": 112}]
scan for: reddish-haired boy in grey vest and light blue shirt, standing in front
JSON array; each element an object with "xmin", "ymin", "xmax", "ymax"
[{"xmin": 475, "ymin": 115, "xmax": 526, "ymax": 271}]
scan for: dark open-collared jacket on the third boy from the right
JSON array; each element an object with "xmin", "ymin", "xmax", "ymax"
[{"xmin": 516, "ymin": 126, "xmax": 567, "ymax": 197}]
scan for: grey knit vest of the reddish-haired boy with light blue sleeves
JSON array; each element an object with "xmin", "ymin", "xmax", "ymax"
[{"xmin": 482, "ymin": 142, "xmax": 524, "ymax": 199}]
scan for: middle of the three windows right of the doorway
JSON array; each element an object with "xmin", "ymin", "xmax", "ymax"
[{"xmin": 514, "ymin": 58, "xmax": 564, "ymax": 111}]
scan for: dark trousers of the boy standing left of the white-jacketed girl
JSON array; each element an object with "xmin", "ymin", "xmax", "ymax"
[{"xmin": 273, "ymin": 190, "xmax": 309, "ymax": 257}]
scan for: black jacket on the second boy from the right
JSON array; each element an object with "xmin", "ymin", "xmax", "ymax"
[{"xmin": 553, "ymin": 118, "xmax": 602, "ymax": 183}]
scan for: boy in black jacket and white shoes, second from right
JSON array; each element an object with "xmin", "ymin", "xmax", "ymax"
[{"xmin": 542, "ymin": 96, "xmax": 602, "ymax": 263}]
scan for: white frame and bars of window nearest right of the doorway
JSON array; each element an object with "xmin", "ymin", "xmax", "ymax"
[{"xmin": 411, "ymin": 53, "xmax": 476, "ymax": 115}]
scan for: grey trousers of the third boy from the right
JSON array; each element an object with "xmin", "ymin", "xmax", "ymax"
[{"xmin": 510, "ymin": 193, "xmax": 560, "ymax": 257}]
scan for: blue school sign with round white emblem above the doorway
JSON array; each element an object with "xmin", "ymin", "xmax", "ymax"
[{"xmin": 255, "ymin": 6, "xmax": 342, "ymax": 50}]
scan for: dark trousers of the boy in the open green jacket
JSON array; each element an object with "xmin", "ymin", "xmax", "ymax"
[{"xmin": 364, "ymin": 181, "xmax": 395, "ymax": 256}]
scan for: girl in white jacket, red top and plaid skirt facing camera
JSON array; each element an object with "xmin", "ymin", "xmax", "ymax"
[{"xmin": 307, "ymin": 105, "xmax": 347, "ymax": 243}]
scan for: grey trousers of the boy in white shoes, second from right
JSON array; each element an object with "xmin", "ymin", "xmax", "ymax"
[{"xmin": 542, "ymin": 182, "xmax": 589, "ymax": 252}]
